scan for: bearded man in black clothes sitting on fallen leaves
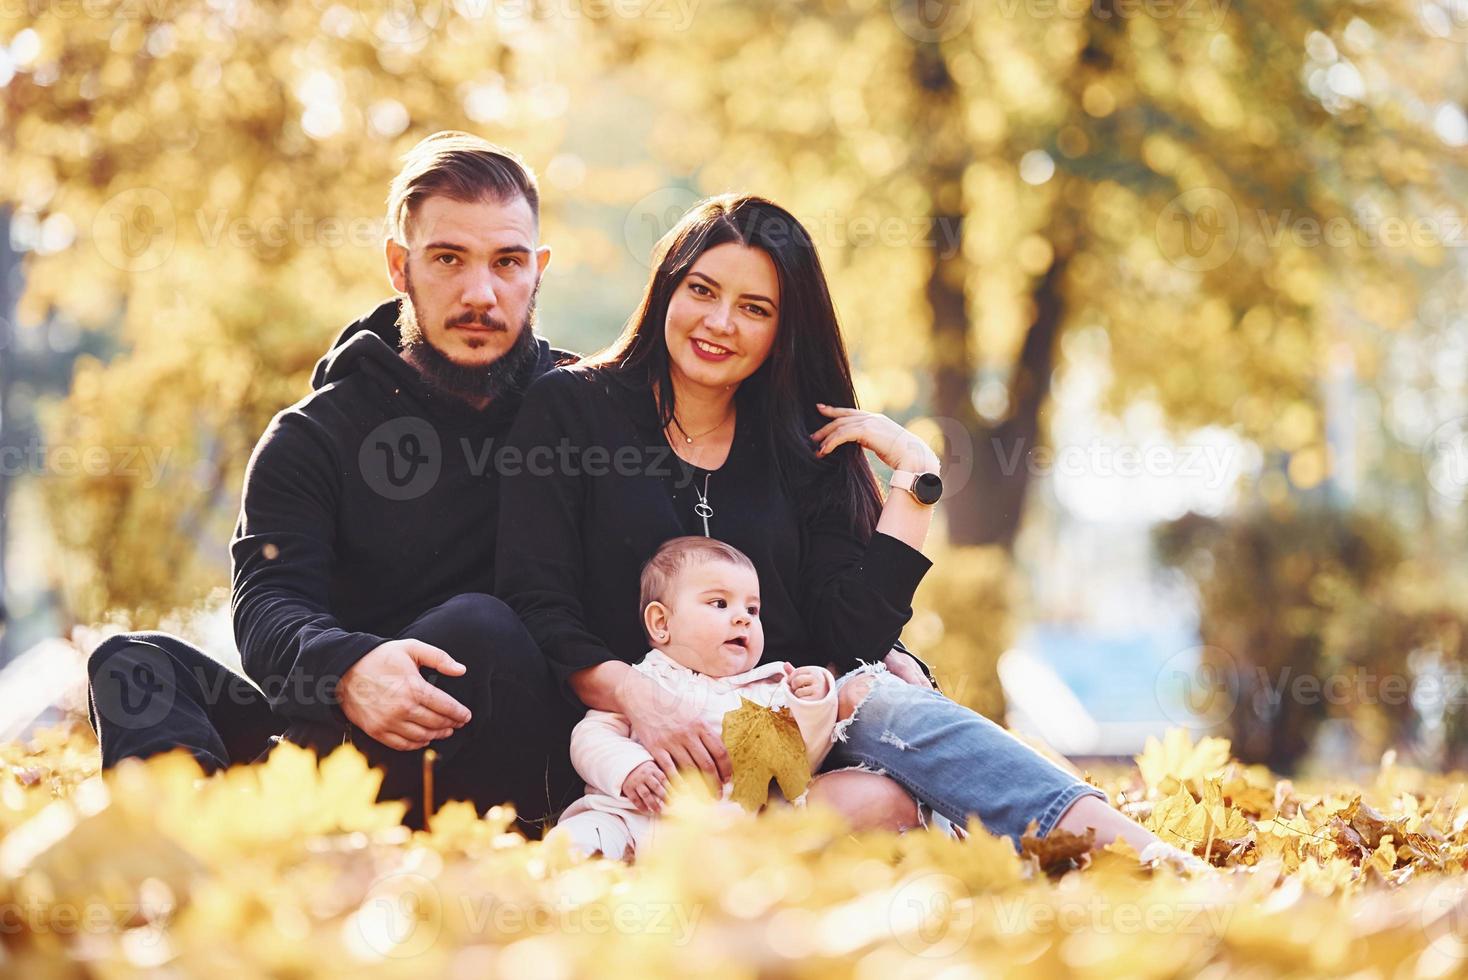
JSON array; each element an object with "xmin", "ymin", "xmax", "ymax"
[{"xmin": 88, "ymin": 132, "xmax": 580, "ymax": 833}]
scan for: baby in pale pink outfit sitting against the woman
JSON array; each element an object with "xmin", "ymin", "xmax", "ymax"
[{"xmin": 551, "ymin": 537, "xmax": 837, "ymax": 858}]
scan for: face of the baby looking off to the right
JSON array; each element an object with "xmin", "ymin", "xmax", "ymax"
[{"xmin": 653, "ymin": 560, "xmax": 765, "ymax": 678}]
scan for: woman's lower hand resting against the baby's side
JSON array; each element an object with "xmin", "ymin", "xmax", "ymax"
[{"xmin": 617, "ymin": 670, "xmax": 734, "ymax": 785}]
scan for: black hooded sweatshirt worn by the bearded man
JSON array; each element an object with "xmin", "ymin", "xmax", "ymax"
[{"xmin": 230, "ymin": 301, "xmax": 570, "ymax": 725}]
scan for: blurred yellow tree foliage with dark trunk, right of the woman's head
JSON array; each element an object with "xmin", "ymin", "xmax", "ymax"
[{"xmin": 596, "ymin": 0, "xmax": 1458, "ymax": 547}]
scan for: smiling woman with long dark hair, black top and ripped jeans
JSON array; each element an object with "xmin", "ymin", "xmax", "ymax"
[{"xmin": 496, "ymin": 195, "xmax": 1182, "ymax": 860}]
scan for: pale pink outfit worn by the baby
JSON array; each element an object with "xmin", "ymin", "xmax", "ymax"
[{"xmin": 551, "ymin": 650, "xmax": 837, "ymax": 858}]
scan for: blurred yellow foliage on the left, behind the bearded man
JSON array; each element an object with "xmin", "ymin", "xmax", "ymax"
[{"xmin": 0, "ymin": 3, "xmax": 604, "ymax": 624}]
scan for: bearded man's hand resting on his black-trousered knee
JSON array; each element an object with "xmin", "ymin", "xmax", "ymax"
[{"xmin": 338, "ymin": 640, "xmax": 470, "ymax": 753}]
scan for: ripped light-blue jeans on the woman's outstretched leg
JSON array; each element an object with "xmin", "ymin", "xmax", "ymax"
[{"xmin": 822, "ymin": 663, "xmax": 1105, "ymax": 848}]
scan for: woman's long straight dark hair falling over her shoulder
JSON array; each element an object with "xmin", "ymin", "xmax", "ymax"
[{"xmin": 586, "ymin": 194, "xmax": 881, "ymax": 540}]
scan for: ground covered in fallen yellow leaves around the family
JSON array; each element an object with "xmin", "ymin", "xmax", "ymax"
[{"xmin": 0, "ymin": 729, "xmax": 1468, "ymax": 980}]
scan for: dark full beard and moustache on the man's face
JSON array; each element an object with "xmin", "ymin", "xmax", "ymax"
[{"xmin": 398, "ymin": 270, "xmax": 540, "ymax": 403}]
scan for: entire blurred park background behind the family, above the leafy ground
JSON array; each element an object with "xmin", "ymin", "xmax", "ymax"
[{"xmin": 0, "ymin": 0, "xmax": 1468, "ymax": 773}]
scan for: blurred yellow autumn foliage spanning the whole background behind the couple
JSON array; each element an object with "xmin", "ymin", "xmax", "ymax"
[{"xmin": 0, "ymin": 0, "xmax": 1461, "ymax": 674}]
